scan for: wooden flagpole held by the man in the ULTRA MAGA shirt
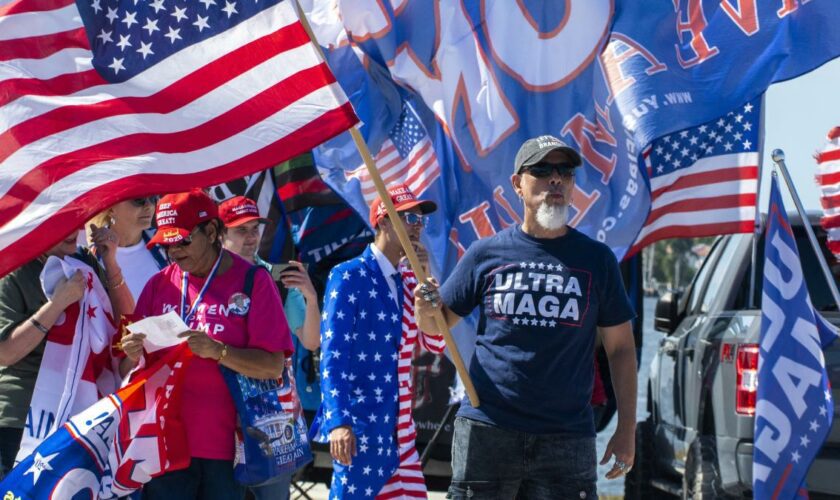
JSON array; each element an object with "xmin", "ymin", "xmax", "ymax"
[{"xmin": 295, "ymin": 0, "xmax": 480, "ymax": 408}]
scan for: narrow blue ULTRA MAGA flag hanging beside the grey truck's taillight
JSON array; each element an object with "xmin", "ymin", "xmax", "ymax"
[{"xmin": 753, "ymin": 175, "xmax": 837, "ymax": 498}]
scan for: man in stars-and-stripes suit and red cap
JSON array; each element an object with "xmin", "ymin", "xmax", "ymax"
[{"xmin": 312, "ymin": 185, "xmax": 444, "ymax": 498}]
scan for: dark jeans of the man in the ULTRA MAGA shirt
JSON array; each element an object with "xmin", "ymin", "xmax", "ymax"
[{"xmin": 447, "ymin": 417, "xmax": 598, "ymax": 500}]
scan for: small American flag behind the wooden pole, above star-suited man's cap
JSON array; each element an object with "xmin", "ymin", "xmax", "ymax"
[{"xmin": 345, "ymin": 101, "xmax": 440, "ymax": 204}]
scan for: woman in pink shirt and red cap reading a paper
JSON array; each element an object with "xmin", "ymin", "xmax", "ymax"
[{"xmin": 122, "ymin": 190, "xmax": 293, "ymax": 500}]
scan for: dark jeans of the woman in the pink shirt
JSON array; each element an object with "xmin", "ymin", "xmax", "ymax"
[{"xmin": 143, "ymin": 457, "xmax": 245, "ymax": 500}]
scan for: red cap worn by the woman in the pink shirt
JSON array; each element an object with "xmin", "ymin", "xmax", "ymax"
[{"xmin": 146, "ymin": 189, "xmax": 219, "ymax": 248}]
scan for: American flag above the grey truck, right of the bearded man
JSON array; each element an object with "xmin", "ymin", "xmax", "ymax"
[{"xmin": 628, "ymin": 99, "xmax": 761, "ymax": 255}]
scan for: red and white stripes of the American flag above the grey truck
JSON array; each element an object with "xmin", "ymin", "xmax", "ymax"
[{"xmin": 628, "ymin": 153, "xmax": 758, "ymax": 255}]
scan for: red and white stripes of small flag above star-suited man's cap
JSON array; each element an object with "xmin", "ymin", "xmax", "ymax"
[{"xmin": 344, "ymin": 136, "xmax": 440, "ymax": 205}]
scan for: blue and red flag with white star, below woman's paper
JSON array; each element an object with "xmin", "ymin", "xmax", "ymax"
[{"xmin": 0, "ymin": 343, "xmax": 192, "ymax": 500}]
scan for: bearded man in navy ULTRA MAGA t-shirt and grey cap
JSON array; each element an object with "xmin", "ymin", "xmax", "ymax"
[{"xmin": 415, "ymin": 135, "xmax": 636, "ymax": 500}]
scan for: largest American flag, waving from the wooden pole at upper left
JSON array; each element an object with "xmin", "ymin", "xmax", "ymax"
[{"xmin": 0, "ymin": 0, "xmax": 357, "ymax": 275}]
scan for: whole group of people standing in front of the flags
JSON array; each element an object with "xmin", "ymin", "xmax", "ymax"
[{"xmin": 0, "ymin": 136, "xmax": 636, "ymax": 499}]
